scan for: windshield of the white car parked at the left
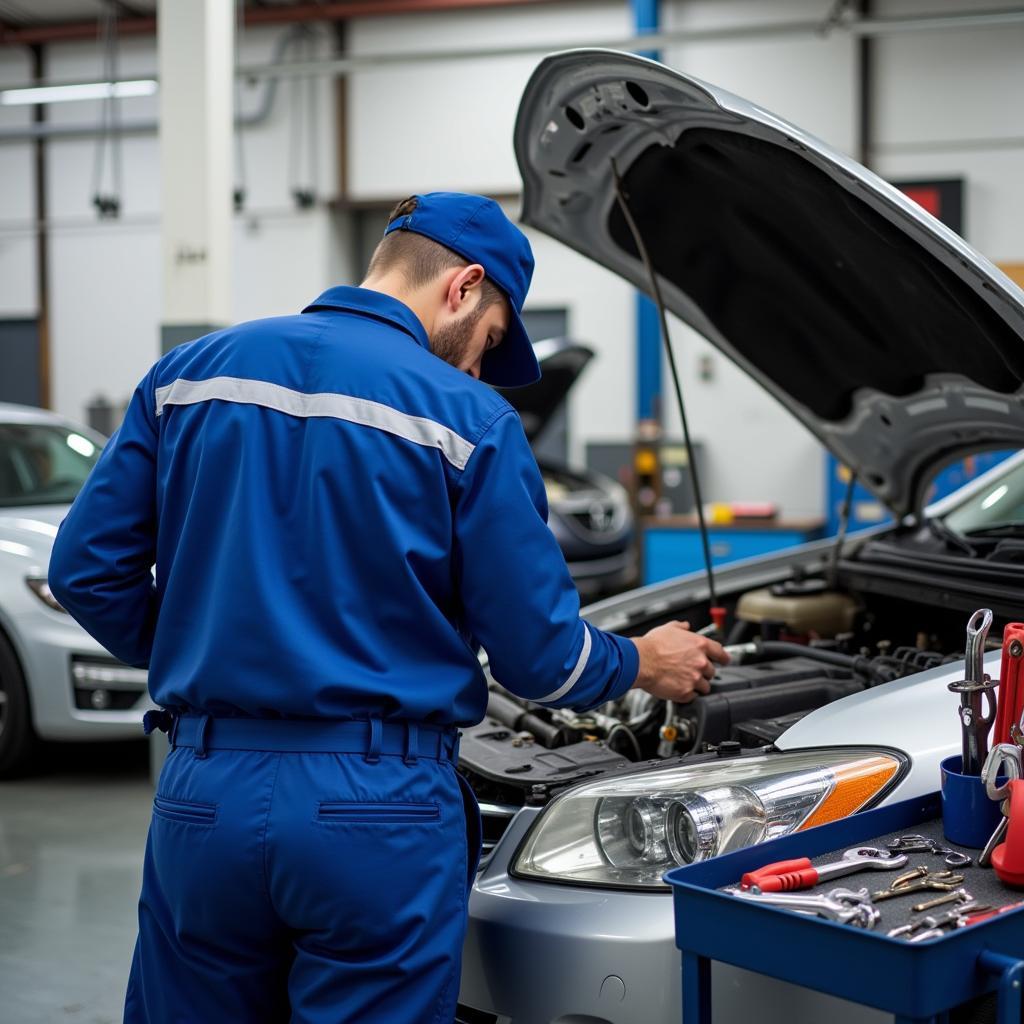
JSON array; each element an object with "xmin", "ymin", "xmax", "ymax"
[{"xmin": 0, "ymin": 423, "xmax": 100, "ymax": 508}]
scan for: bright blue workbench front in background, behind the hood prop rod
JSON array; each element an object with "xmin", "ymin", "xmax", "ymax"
[{"xmin": 643, "ymin": 519, "xmax": 824, "ymax": 584}]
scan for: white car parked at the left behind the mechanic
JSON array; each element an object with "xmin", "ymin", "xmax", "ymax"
[{"xmin": 0, "ymin": 403, "xmax": 152, "ymax": 778}]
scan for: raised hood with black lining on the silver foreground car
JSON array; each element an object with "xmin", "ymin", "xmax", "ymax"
[{"xmin": 515, "ymin": 50, "xmax": 1024, "ymax": 515}]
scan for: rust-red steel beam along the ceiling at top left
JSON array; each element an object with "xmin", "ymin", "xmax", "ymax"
[{"xmin": 0, "ymin": 0, "xmax": 552, "ymax": 46}]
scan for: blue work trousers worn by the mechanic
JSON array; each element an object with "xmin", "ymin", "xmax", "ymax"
[{"xmin": 125, "ymin": 720, "xmax": 479, "ymax": 1024}]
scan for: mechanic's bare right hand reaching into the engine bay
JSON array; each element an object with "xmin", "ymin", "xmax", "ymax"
[{"xmin": 633, "ymin": 623, "xmax": 729, "ymax": 703}]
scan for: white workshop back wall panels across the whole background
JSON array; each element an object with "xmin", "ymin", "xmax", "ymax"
[{"xmin": 0, "ymin": 0, "xmax": 1024, "ymax": 515}]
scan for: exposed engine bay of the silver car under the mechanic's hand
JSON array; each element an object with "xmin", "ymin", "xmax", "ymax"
[{"xmin": 461, "ymin": 572, "xmax": 964, "ymax": 807}]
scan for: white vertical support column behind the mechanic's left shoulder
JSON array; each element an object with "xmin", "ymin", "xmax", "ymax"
[{"xmin": 157, "ymin": 0, "xmax": 236, "ymax": 352}]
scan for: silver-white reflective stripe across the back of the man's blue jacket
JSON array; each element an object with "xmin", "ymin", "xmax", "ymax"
[{"xmin": 155, "ymin": 377, "xmax": 473, "ymax": 469}]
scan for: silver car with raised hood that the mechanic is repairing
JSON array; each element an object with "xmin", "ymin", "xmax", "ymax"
[{"xmin": 459, "ymin": 51, "xmax": 1024, "ymax": 1024}]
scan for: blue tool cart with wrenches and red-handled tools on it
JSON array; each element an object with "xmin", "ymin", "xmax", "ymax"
[{"xmin": 666, "ymin": 608, "xmax": 1024, "ymax": 1024}]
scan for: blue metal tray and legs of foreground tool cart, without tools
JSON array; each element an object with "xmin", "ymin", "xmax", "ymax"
[{"xmin": 666, "ymin": 794, "xmax": 1024, "ymax": 1024}]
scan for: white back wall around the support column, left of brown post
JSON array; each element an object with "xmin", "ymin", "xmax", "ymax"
[{"xmin": 0, "ymin": 28, "xmax": 338, "ymax": 418}]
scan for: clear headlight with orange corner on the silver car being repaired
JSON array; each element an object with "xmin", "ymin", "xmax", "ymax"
[{"xmin": 513, "ymin": 748, "xmax": 907, "ymax": 889}]
